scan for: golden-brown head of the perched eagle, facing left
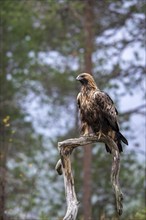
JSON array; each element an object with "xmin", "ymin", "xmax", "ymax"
[{"xmin": 76, "ymin": 73, "xmax": 97, "ymax": 88}]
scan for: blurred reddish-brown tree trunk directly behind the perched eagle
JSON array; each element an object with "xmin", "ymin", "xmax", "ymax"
[{"xmin": 83, "ymin": 0, "xmax": 94, "ymax": 220}]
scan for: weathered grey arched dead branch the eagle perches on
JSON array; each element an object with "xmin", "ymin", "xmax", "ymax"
[{"xmin": 55, "ymin": 134, "xmax": 123, "ymax": 220}]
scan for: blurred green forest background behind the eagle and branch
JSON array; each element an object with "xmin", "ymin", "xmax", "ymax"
[{"xmin": 0, "ymin": 0, "xmax": 146, "ymax": 220}]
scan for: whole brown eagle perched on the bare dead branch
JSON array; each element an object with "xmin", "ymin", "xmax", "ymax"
[{"xmin": 76, "ymin": 73, "xmax": 128, "ymax": 153}]
